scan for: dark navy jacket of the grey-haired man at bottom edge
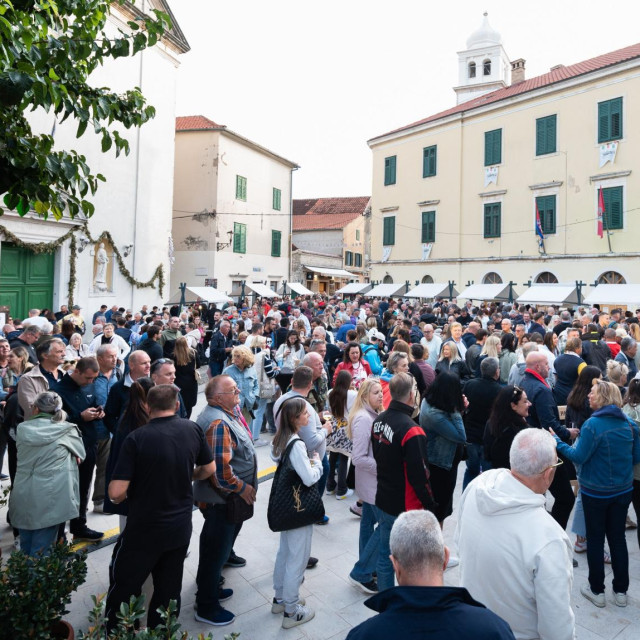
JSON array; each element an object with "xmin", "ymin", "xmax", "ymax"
[{"xmin": 347, "ymin": 587, "xmax": 514, "ymax": 640}]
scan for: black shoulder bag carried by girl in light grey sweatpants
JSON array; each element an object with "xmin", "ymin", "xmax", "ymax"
[{"xmin": 267, "ymin": 438, "xmax": 324, "ymax": 531}]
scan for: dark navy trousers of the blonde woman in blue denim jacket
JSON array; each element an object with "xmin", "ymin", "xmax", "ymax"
[{"xmin": 581, "ymin": 491, "xmax": 631, "ymax": 593}]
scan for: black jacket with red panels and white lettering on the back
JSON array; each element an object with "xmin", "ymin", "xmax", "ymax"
[{"xmin": 371, "ymin": 400, "xmax": 434, "ymax": 516}]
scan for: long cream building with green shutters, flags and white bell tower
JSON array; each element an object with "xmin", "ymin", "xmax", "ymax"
[{"xmin": 368, "ymin": 15, "xmax": 640, "ymax": 302}]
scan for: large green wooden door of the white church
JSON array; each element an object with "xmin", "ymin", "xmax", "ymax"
[{"xmin": 0, "ymin": 243, "xmax": 55, "ymax": 319}]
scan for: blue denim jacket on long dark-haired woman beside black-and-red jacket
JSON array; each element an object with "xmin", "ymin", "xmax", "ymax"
[{"xmin": 420, "ymin": 400, "xmax": 467, "ymax": 470}]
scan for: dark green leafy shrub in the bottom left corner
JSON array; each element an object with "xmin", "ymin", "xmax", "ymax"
[{"xmin": 0, "ymin": 544, "xmax": 87, "ymax": 640}]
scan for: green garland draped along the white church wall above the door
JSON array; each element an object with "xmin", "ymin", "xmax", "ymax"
[{"xmin": 0, "ymin": 224, "xmax": 165, "ymax": 307}]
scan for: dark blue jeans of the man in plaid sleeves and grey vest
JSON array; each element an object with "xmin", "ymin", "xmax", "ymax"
[{"xmin": 196, "ymin": 504, "xmax": 241, "ymax": 616}]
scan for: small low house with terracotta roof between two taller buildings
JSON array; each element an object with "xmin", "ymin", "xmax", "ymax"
[{"xmin": 291, "ymin": 196, "xmax": 370, "ymax": 294}]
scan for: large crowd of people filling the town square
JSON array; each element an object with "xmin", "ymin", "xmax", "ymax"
[{"xmin": 0, "ymin": 295, "xmax": 640, "ymax": 640}]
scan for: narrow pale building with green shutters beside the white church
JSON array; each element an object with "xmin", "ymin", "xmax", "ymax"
[{"xmin": 172, "ymin": 115, "xmax": 298, "ymax": 296}]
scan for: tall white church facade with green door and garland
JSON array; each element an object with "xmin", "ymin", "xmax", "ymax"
[{"xmin": 0, "ymin": 0, "xmax": 189, "ymax": 318}]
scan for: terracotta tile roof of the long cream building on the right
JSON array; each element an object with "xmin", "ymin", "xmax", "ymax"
[{"xmin": 371, "ymin": 43, "xmax": 640, "ymax": 141}]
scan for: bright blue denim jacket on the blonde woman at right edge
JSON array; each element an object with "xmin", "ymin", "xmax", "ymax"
[{"xmin": 556, "ymin": 405, "xmax": 640, "ymax": 498}]
